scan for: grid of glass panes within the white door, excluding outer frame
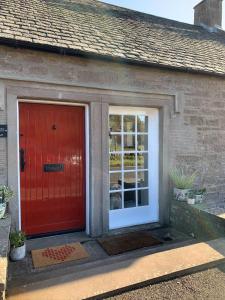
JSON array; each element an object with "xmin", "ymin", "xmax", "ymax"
[{"xmin": 109, "ymin": 113, "xmax": 149, "ymax": 210}]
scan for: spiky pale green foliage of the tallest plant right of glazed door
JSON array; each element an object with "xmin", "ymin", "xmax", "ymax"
[{"xmin": 169, "ymin": 168, "xmax": 197, "ymax": 190}]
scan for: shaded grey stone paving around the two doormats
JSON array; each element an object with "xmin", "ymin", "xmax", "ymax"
[{"xmin": 8, "ymin": 227, "xmax": 192, "ymax": 288}]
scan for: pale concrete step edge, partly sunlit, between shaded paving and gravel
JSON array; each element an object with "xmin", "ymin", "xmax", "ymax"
[{"xmin": 7, "ymin": 238, "xmax": 225, "ymax": 300}]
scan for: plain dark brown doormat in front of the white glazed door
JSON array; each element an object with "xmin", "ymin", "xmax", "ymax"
[{"xmin": 98, "ymin": 231, "xmax": 162, "ymax": 255}]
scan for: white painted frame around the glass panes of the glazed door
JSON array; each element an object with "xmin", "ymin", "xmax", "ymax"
[{"xmin": 109, "ymin": 106, "xmax": 159, "ymax": 229}]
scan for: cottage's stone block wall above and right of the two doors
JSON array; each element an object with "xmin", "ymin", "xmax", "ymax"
[{"xmin": 0, "ymin": 46, "xmax": 225, "ymax": 227}]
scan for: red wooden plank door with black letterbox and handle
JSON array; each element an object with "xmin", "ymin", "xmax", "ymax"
[{"xmin": 19, "ymin": 103, "xmax": 85, "ymax": 235}]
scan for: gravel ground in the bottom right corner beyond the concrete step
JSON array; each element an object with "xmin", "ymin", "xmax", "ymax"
[{"xmin": 107, "ymin": 264, "xmax": 225, "ymax": 300}]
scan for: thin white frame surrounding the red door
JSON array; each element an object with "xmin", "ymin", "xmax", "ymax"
[{"xmin": 17, "ymin": 98, "xmax": 90, "ymax": 234}]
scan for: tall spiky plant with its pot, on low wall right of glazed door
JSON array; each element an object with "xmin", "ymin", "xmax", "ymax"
[{"xmin": 170, "ymin": 168, "xmax": 196, "ymax": 201}]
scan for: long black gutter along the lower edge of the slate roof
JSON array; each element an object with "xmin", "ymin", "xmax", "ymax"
[{"xmin": 0, "ymin": 37, "xmax": 225, "ymax": 78}]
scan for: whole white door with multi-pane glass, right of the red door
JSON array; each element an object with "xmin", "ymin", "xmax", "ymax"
[{"xmin": 109, "ymin": 107, "xmax": 159, "ymax": 229}]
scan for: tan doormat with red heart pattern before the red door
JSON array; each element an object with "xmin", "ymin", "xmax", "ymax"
[{"xmin": 31, "ymin": 243, "xmax": 89, "ymax": 268}]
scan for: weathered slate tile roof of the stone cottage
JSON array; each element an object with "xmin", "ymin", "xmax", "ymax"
[{"xmin": 0, "ymin": 0, "xmax": 225, "ymax": 75}]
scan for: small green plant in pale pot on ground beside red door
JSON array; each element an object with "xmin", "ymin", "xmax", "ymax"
[{"xmin": 9, "ymin": 231, "xmax": 26, "ymax": 261}]
